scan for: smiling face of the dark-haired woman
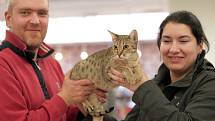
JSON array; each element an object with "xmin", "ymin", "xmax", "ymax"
[{"xmin": 160, "ymin": 22, "xmax": 203, "ymax": 75}]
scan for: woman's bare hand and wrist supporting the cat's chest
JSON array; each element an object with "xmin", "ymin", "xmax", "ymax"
[{"xmin": 108, "ymin": 68, "xmax": 148, "ymax": 91}]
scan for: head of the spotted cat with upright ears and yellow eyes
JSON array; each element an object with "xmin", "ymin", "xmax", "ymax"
[{"xmin": 109, "ymin": 30, "xmax": 138, "ymax": 60}]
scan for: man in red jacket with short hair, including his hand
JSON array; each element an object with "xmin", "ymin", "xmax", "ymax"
[{"xmin": 0, "ymin": 0, "xmax": 95, "ymax": 121}]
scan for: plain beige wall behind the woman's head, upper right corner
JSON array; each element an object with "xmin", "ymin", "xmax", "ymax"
[{"xmin": 169, "ymin": 0, "xmax": 215, "ymax": 65}]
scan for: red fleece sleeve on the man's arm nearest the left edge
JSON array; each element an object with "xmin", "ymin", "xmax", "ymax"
[{"xmin": 0, "ymin": 56, "xmax": 82, "ymax": 121}]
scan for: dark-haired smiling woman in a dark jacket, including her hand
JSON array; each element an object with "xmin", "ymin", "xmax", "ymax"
[{"xmin": 84, "ymin": 11, "xmax": 215, "ymax": 121}]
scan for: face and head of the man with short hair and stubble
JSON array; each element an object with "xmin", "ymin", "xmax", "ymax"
[{"xmin": 5, "ymin": 0, "xmax": 48, "ymax": 50}]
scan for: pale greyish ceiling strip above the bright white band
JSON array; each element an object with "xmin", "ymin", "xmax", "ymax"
[{"xmin": 0, "ymin": 0, "xmax": 168, "ymax": 20}]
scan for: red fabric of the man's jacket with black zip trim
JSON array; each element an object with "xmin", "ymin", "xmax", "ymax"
[{"xmin": 0, "ymin": 31, "xmax": 78, "ymax": 121}]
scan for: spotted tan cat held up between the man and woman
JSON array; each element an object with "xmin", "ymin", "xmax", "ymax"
[{"xmin": 69, "ymin": 30, "xmax": 143, "ymax": 121}]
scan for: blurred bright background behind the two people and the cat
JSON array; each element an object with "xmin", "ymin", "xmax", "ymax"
[{"xmin": 0, "ymin": 0, "xmax": 215, "ymax": 120}]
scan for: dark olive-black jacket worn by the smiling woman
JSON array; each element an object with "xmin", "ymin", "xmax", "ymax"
[{"xmin": 83, "ymin": 52, "xmax": 215, "ymax": 121}]
